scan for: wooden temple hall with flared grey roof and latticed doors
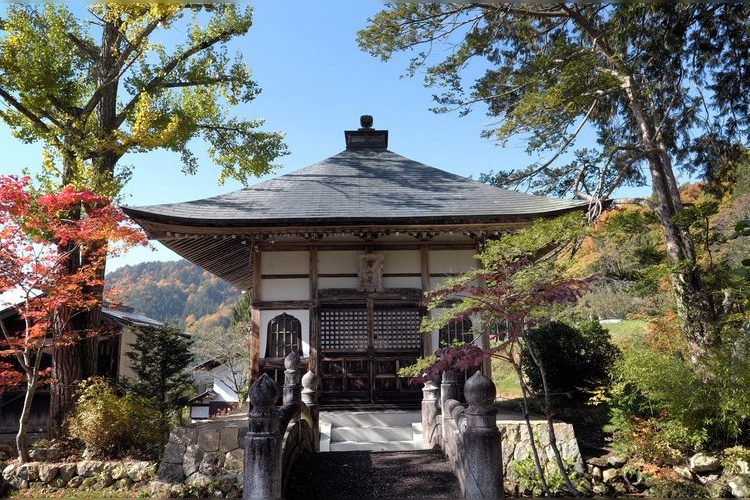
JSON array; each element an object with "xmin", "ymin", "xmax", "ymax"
[{"xmin": 123, "ymin": 117, "xmax": 583, "ymax": 405}]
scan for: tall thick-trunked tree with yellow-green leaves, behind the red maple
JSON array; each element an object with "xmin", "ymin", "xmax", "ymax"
[{"xmin": 0, "ymin": 3, "xmax": 286, "ymax": 428}]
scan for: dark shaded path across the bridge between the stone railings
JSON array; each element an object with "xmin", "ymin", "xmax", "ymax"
[{"xmin": 284, "ymin": 450, "xmax": 461, "ymax": 499}]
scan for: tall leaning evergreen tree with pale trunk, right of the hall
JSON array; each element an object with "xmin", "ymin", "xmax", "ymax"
[{"xmin": 359, "ymin": 3, "xmax": 750, "ymax": 359}]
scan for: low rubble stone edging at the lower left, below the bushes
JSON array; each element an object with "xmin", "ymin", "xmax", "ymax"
[{"xmin": 2, "ymin": 460, "xmax": 156, "ymax": 491}]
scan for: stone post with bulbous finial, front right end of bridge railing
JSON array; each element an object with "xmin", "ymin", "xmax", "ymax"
[{"xmin": 462, "ymin": 372, "xmax": 504, "ymax": 498}]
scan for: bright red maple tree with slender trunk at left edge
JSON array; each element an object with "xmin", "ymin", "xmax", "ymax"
[{"xmin": 0, "ymin": 176, "xmax": 146, "ymax": 462}]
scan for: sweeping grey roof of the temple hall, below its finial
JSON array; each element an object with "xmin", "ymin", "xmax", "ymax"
[{"xmin": 125, "ymin": 149, "xmax": 581, "ymax": 226}]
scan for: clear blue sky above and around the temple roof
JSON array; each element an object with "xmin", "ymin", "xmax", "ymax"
[{"xmin": 0, "ymin": 0, "xmax": 647, "ymax": 270}]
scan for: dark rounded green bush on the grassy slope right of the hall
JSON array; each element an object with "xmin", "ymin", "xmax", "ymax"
[{"xmin": 521, "ymin": 320, "xmax": 620, "ymax": 393}]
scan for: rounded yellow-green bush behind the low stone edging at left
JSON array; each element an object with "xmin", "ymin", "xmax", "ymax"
[{"xmin": 68, "ymin": 377, "xmax": 160, "ymax": 458}]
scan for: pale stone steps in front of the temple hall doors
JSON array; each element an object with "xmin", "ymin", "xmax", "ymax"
[{"xmin": 320, "ymin": 410, "xmax": 432, "ymax": 451}]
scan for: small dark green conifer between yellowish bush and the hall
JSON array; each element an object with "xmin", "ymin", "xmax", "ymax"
[{"xmin": 127, "ymin": 325, "xmax": 193, "ymax": 446}]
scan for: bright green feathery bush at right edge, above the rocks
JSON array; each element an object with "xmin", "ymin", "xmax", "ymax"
[{"xmin": 606, "ymin": 334, "xmax": 750, "ymax": 463}]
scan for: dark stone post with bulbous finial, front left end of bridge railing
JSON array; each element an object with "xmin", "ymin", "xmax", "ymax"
[{"xmin": 243, "ymin": 373, "xmax": 284, "ymax": 498}]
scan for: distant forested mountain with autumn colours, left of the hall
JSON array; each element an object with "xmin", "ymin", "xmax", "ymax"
[{"xmin": 105, "ymin": 260, "xmax": 241, "ymax": 332}]
